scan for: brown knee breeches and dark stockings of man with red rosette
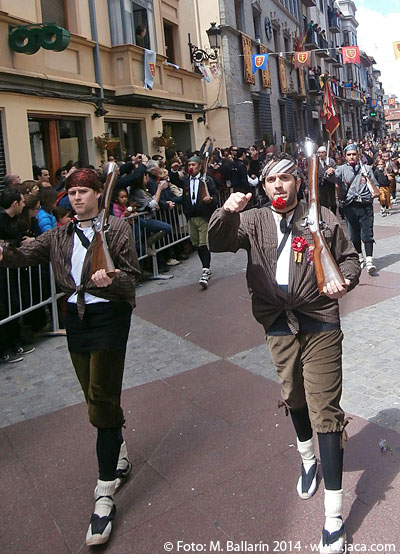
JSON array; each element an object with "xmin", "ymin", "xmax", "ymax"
[{"xmin": 267, "ymin": 330, "xmax": 345, "ymax": 490}]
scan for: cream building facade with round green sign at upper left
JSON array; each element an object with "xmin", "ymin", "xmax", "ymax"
[{"xmin": 0, "ymin": 0, "xmax": 209, "ymax": 180}]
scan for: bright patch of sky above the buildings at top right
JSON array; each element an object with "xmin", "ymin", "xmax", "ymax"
[{"xmin": 353, "ymin": 0, "xmax": 400, "ymax": 101}]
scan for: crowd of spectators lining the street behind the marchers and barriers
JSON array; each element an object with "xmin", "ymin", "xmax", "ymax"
[{"xmin": 0, "ymin": 131, "xmax": 400, "ymax": 362}]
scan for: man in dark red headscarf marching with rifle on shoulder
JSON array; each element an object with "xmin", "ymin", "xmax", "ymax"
[{"xmin": 0, "ymin": 169, "xmax": 140, "ymax": 546}]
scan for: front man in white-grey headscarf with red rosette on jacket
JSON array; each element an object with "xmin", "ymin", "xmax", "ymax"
[{"xmin": 208, "ymin": 154, "xmax": 360, "ymax": 554}]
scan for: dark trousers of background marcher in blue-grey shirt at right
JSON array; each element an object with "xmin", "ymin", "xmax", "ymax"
[{"xmin": 343, "ymin": 202, "xmax": 374, "ymax": 256}]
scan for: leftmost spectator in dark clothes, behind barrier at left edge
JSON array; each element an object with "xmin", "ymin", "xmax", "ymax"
[{"xmin": 0, "ymin": 189, "xmax": 35, "ymax": 363}]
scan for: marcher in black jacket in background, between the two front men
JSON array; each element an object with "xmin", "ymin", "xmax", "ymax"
[{"xmin": 170, "ymin": 156, "xmax": 218, "ymax": 290}]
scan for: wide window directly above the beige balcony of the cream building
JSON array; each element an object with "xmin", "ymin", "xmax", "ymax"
[{"xmin": 108, "ymin": 0, "xmax": 152, "ymax": 48}]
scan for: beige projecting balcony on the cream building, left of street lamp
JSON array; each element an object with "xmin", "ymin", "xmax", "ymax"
[{"xmin": 102, "ymin": 44, "xmax": 204, "ymax": 104}]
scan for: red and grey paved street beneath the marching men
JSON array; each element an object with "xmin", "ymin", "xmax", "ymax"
[{"xmin": 0, "ymin": 199, "xmax": 400, "ymax": 554}]
